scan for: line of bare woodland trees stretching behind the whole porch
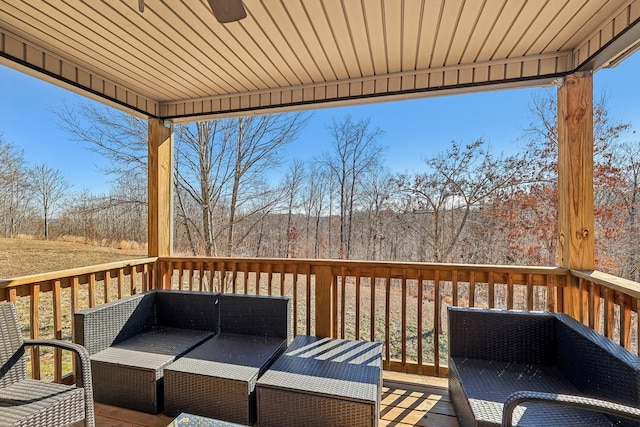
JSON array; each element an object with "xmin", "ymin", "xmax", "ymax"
[{"xmin": 0, "ymin": 91, "xmax": 640, "ymax": 280}]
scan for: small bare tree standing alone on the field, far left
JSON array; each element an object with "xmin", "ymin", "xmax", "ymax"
[{"xmin": 29, "ymin": 165, "xmax": 71, "ymax": 240}]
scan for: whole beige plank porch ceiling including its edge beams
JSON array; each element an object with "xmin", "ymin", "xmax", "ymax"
[{"xmin": 0, "ymin": 0, "xmax": 640, "ymax": 121}]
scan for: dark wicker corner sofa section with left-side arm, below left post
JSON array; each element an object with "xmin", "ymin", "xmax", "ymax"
[{"xmin": 74, "ymin": 290, "xmax": 220, "ymax": 413}]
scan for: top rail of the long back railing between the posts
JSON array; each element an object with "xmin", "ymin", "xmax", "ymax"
[{"xmin": 159, "ymin": 256, "xmax": 569, "ymax": 276}]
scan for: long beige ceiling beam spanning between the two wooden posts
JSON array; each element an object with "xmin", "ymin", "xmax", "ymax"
[{"xmin": 160, "ymin": 51, "xmax": 573, "ymax": 122}]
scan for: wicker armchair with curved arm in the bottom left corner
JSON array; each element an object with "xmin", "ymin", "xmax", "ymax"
[{"xmin": 0, "ymin": 303, "xmax": 95, "ymax": 427}]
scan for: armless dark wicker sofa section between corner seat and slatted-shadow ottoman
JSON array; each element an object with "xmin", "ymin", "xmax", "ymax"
[{"xmin": 164, "ymin": 294, "xmax": 291, "ymax": 425}]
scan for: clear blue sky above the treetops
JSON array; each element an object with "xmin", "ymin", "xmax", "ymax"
[{"xmin": 0, "ymin": 53, "xmax": 640, "ymax": 193}]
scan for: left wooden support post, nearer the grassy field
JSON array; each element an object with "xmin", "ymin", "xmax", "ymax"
[{"xmin": 148, "ymin": 119, "xmax": 173, "ymax": 287}]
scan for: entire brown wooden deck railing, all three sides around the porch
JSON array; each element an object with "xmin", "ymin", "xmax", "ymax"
[{"xmin": 0, "ymin": 257, "xmax": 640, "ymax": 380}]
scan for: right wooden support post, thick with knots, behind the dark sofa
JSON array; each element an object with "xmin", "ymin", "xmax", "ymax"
[{"xmin": 558, "ymin": 73, "xmax": 595, "ymax": 321}]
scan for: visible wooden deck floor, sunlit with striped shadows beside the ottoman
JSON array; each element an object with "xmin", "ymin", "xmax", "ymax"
[{"xmin": 84, "ymin": 371, "xmax": 458, "ymax": 427}]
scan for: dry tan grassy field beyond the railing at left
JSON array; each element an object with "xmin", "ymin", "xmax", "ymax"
[{"xmin": 0, "ymin": 238, "xmax": 146, "ymax": 279}]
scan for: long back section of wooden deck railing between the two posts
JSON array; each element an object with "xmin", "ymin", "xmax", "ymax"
[{"xmin": 159, "ymin": 257, "xmax": 569, "ymax": 376}]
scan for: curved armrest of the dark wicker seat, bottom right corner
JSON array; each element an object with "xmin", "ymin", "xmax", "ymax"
[{"xmin": 502, "ymin": 391, "xmax": 640, "ymax": 427}]
